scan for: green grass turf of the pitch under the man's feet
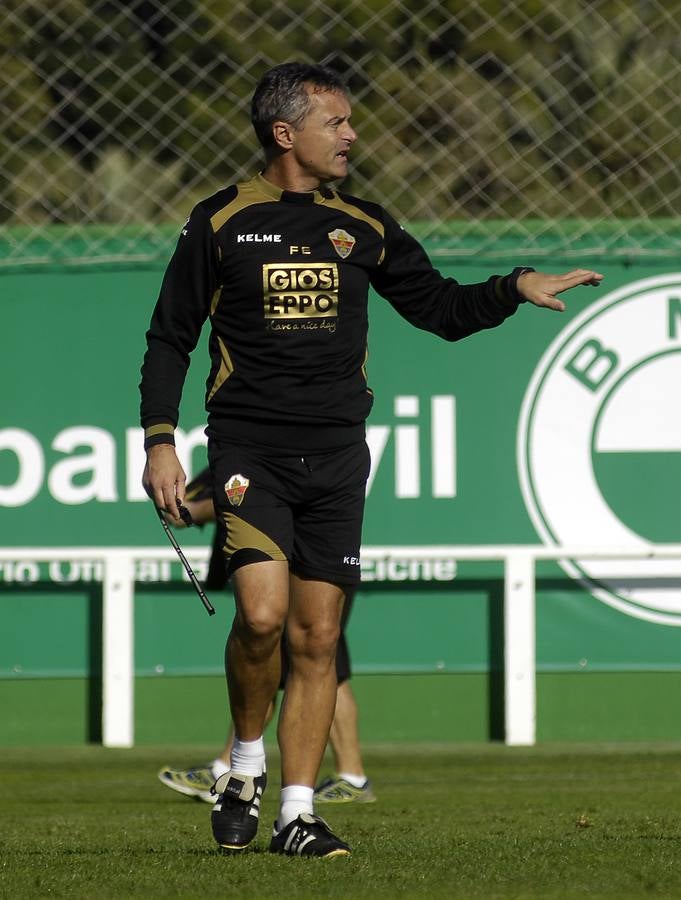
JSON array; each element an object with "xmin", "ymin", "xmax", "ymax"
[{"xmin": 0, "ymin": 744, "xmax": 681, "ymax": 900}]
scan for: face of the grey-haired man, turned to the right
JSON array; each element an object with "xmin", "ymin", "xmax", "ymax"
[{"xmin": 291, "ymin": 85, "xmax": 357, "ymax": 182}]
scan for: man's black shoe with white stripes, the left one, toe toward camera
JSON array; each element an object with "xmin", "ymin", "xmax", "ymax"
[{"xmin": 210, "ymin": 772, "xmax": 267, "ymax": 850}]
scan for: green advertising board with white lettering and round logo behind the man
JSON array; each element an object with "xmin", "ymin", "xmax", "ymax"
[{"xmin": 0, "ymin": 236, "xmax": 681, "ymax": 740}]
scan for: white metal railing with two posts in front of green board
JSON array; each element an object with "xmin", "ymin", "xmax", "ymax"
[{"xmin": 0, "ymin": 544, "xmax": 681, "ymax": 747}]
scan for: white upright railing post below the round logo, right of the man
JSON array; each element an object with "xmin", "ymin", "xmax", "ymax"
[{"xmin": 504, "ymin": 551, "xmax": 536, "ymax": 746}]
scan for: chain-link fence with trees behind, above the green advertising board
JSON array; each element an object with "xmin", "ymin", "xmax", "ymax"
[{"xmin": 0, "ymin": 0, "xmax": 681, "ymax": 266}]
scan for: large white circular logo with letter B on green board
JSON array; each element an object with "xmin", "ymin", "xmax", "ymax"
[{"xmin": 518, "ymin": 274, "xmax": 681, "ymax": 625}]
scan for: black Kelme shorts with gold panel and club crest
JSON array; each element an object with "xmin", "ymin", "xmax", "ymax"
[{"xmin": 208, "ymin": 440, "xmax": 370, "ymax": 585}]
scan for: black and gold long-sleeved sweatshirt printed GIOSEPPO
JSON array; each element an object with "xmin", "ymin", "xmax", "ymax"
[{"xmin": 140, "ymin": 175, "xmax": 526, "ymax": 452}]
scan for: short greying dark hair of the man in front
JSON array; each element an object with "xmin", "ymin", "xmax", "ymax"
[{"xmin": 251, "ymin": 62, "xmax": 347, "ymax": 150}]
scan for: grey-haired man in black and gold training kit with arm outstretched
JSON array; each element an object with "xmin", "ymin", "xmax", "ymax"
[{"xmin": 141, "ymin": 63, "xmax": 601, "ymax": 857}]
